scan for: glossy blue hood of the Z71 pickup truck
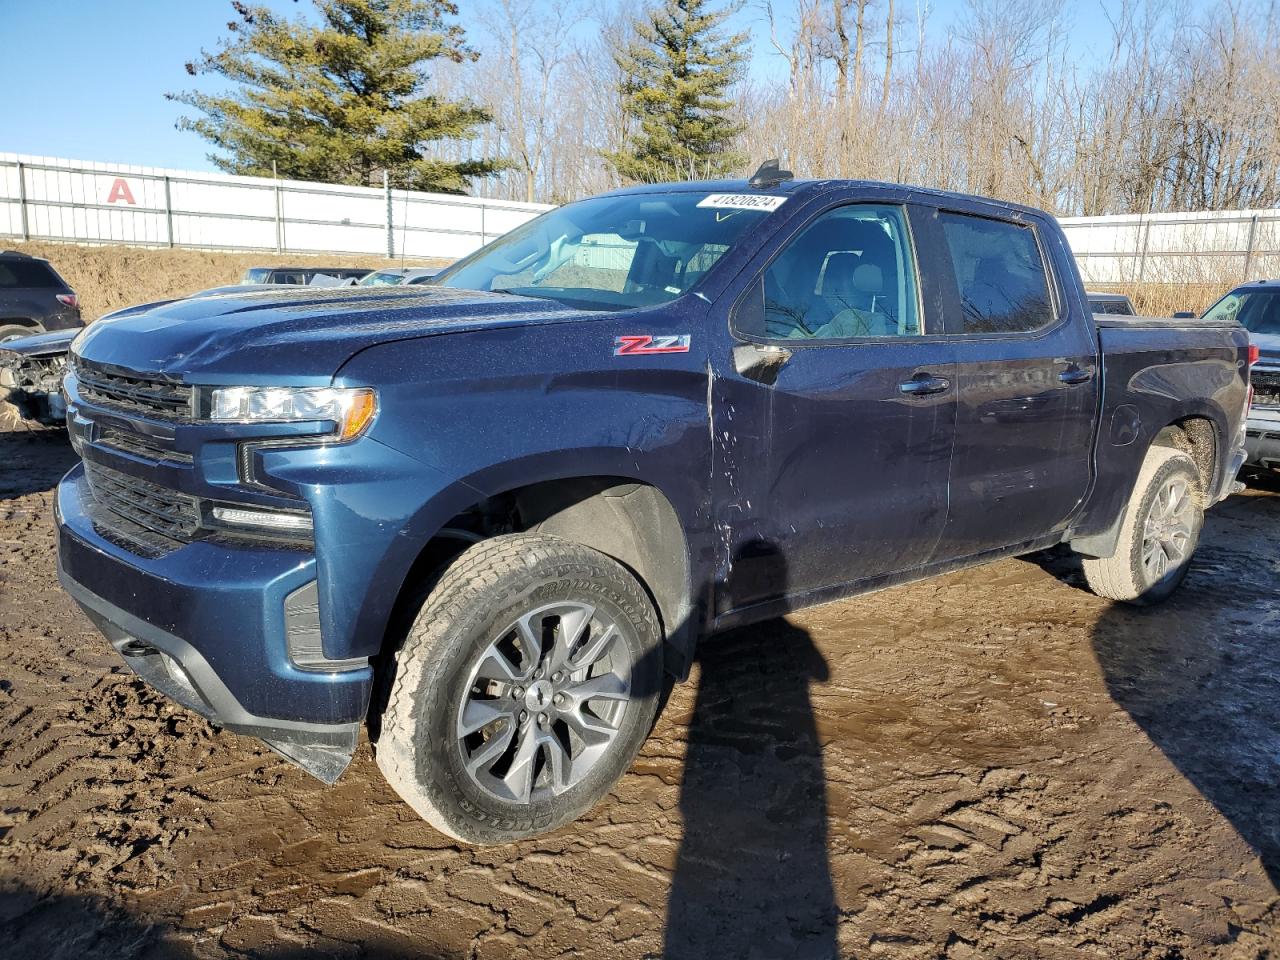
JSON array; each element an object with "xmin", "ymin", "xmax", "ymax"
[{"xmin": 74, "ymin": 287, "xmax": 588, "ymax": 385}]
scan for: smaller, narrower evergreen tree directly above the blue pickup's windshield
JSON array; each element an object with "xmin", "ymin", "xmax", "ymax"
[{"xmin": 604, "ymin": 0, "xmax": 748, "ymax": 183}]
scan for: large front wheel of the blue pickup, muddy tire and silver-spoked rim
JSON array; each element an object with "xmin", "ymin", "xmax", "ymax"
[{"xmin": 376, "ymin": 534, "xmax": 662, "ymax": 844}]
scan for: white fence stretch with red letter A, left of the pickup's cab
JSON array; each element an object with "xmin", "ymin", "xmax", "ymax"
[{"xmin": 0, "ymin": 154, "xmax": 550, "ymax": 260}]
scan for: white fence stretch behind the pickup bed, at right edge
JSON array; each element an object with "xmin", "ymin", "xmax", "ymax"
[{"xmin": 1061, "ymin": 210, "xmax": 1280, "ymax": 285}]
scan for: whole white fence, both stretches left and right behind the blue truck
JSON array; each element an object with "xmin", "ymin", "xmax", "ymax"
[{"xmin": 0, "ymin": 154, "xmax": 1280, "ymax": 285}]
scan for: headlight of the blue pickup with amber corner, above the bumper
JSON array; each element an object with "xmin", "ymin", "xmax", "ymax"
[{"xmin": 209, "ymin": 387, "xmax": 378, "ymax": 440}]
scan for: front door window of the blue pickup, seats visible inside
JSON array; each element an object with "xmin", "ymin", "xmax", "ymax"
[{"xmin": 735, "ymin": 204, "xmax": 922, "ymax": 340}]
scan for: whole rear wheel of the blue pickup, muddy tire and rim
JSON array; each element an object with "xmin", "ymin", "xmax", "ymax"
[{"xmin": 1083, "ymin": 447, "xmax": 1204, "ymax": 605}]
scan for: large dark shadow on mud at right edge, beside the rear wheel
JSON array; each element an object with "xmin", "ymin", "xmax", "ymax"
[{"xmin": 1092, "ymin": 497, "xmax": 1280, "ymax": 890}]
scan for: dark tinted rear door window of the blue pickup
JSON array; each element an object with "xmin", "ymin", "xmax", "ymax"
[{"xmin": 938, "ymin": 212, "xmax": 1056, "ymax": 333}]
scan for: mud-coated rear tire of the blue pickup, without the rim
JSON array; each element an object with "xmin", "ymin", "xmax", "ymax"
[{"xmin": 1083, "ymin": 447, "xmax": 1204, "ymax": 605}]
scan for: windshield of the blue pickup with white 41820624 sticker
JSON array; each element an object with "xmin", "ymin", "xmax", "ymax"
[{"xmin": 435, "ymin": 192, "xmax": 786, "ymax": 310}]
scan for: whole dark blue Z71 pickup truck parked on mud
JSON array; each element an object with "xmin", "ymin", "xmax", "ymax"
[{"xmin": 56, "ymin": 169, "xmax": 1249, "ymax": 844}]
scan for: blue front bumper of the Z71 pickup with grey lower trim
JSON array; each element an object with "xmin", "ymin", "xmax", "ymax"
[{"xmin": 56, "ymin": 465, "xmax": 372, "ymax": 783}]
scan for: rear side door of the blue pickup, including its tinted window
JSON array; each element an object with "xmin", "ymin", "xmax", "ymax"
[{"xmin": 931, "ymin": 210, "xmax": 1101, "ymax": 561}]
